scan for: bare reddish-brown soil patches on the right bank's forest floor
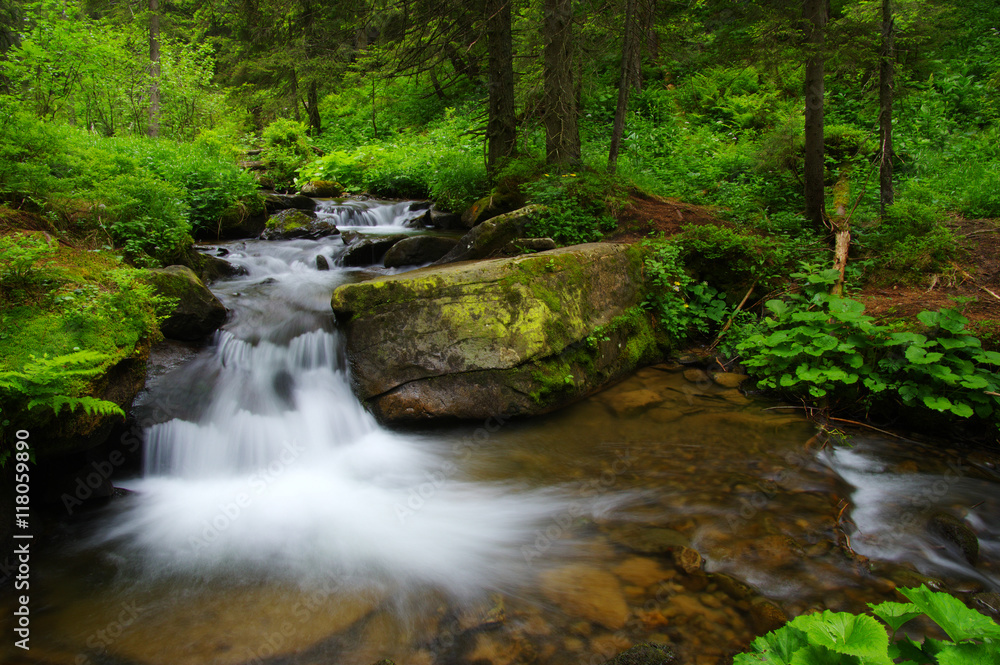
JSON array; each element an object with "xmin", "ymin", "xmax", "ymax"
[{"xmin": 608, "ymin": 189, "xmax": 1000, "ymax": 348}]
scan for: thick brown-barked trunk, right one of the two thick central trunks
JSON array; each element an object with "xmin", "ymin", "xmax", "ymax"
[{"xmin": 542, "ymin": 0, "xmax": 581, "ymax": 166}]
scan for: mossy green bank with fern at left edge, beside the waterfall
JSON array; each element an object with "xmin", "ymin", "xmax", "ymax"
[{"xmin": 0, "ymin": 233, "xmax": 170, "ymax": 440}]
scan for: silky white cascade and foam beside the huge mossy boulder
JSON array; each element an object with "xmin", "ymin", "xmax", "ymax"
[{"xmin": 103, "ymin": 223, "xmax": 580, "ymax": 593}]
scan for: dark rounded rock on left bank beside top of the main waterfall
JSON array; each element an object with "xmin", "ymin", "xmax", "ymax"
[{"xmin": 147, "ymin": 266, "xmax": 226, "ymax": 340}]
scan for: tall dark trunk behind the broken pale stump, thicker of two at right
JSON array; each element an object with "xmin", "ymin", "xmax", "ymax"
[{"xmin": 802, "ymin": 0, "xmax": 827, "ymax": 227}]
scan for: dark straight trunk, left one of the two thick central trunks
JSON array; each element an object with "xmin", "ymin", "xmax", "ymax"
[{"xmin": 484, "ymin": 0, "xmax": 517, "ymax": 180}]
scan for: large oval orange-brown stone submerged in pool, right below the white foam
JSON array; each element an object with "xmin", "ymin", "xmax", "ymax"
[{"xmin": 539, "ymin": 564, "xmax": 628, "ymax": 630}]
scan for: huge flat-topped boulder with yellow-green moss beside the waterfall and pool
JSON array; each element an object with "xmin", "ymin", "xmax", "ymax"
[{"xmin": 332, "ymin": 244, "xmax": 660, "ymax": 422}]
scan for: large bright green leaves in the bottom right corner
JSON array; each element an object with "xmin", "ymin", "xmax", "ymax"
[{"xmin": 733, "ymin": 585, "xmax": 1000, "ymax": 665}]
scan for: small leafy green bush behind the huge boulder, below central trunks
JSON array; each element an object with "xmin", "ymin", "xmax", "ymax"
[{"xmin": 522, "ymin": 171, "xmax": 616, "ymax": 245}]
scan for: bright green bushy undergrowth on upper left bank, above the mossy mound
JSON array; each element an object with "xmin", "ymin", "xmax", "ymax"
[{"xmin": 0, "ymin": 106, "xmax": 263, "ymax": 266}]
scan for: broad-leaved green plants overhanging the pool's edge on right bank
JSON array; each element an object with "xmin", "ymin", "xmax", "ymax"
[{"xmin": 737, "ymin": 270, "xmax": 1000, "ymax": 426}]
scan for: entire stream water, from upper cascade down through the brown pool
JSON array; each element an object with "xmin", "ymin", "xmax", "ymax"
[{"xmin": 5, "ymin": 203, "xmax": 1000, "ymax": 665}]
